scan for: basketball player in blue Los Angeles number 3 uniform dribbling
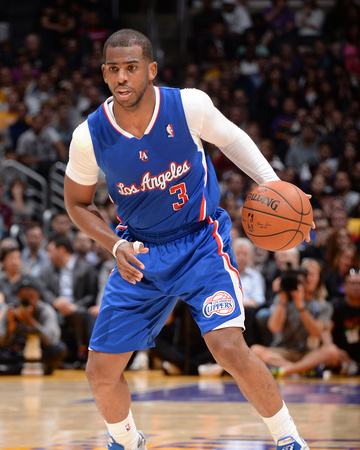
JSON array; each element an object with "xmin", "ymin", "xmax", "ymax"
[{"xmin": 65, "ymin": 29, "xmax": 308, "ymax": 450}]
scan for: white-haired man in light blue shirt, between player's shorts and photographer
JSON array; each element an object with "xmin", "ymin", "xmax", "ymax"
[{"xmin": 232, "ymin": 237, "xmax": 265, "ymax": 346}]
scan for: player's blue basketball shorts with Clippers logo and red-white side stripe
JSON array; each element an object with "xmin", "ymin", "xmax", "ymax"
[{"xmin": 90, "ymin": 208, "xmax": 245, "ymax": 353}]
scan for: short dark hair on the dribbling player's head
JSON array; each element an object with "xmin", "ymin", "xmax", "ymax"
[{"xmin": 103, "ymin": 28, "xmax": 154, "ymax": 62}]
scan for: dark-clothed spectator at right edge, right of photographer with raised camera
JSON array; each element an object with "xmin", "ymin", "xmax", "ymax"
[{"xmin": 325, "ymin": 243, "xmax": 359, "ymax": 298}]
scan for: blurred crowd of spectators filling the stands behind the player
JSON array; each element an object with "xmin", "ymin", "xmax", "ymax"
[{"xmin": 0, "ymin": 0, "xmax": 360, "ymax": 376}]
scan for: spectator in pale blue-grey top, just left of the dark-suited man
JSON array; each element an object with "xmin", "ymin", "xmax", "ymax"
[{"xmin": 21, "ymin": 222, "xmax": 49, "ymax": 278}]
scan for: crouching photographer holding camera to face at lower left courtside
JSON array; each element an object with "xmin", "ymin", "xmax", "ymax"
[{"xmin": 0, "ymin": 277, "xmax": 66, "ymax": 375}]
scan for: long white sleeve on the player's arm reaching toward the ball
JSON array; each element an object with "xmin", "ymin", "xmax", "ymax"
[{"xmin": 181, "ymin": 89, "xmax": 279, "ymax": 184}]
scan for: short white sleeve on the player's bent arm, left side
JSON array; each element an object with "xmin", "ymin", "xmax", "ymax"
[{"xmin": 66, "ymin": 121, "xmax": 99, "ymax": 186}]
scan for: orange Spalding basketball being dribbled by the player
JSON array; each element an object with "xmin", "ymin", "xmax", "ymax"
[{"xmin": 241, "ymin": 181, "xmax": 313, "ymax": 252}]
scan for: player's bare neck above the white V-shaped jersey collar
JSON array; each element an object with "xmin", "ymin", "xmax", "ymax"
[{"xmin": 114, "ymin": 85, "xmax": 156, "ymax": 139}]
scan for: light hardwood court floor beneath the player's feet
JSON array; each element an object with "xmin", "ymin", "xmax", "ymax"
[{"xmin": 0, "ymin": 371, "xmax": 360, "ymax": 450}]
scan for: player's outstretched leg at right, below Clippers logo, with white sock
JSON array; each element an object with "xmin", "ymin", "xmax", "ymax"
[{"xmin": 204, "ymin": 328, "xmax": 308, "ymax": 450}]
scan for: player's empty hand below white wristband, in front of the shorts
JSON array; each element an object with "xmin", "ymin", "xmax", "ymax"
[{"xmin": 116, "ymin": 242, "xmax": 149, "ymax": 284}]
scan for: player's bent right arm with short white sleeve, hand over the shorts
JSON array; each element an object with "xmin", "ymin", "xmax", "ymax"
[{"xmin": 64, "ymin": 124, "xmax": 148, "ymax": 284}]
